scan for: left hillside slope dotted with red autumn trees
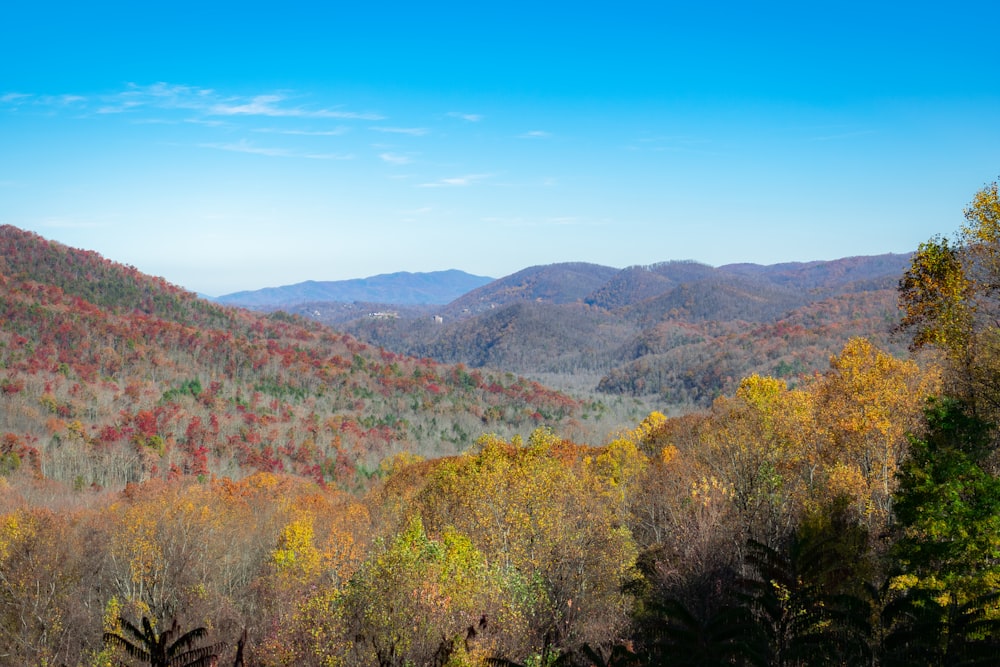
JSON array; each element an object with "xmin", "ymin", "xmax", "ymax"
[{"xmin": 0, "ymin": 227, "xmax": 581, "ymax": 488}]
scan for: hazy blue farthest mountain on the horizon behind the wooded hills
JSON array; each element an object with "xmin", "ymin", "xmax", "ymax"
[{"xmin": 215, "ymin": 269, "xmax": 493, "ymax": 309}]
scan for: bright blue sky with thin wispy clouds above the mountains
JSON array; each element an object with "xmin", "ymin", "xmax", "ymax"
[{"xmin": 0, "ymin": 0, "xmax": 1000, "ymax": 295}]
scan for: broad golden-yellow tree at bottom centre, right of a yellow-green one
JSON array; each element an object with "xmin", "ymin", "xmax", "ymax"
[{"xmin": 420, "ymin": 429, "xmax": 636, "ymax": 657}]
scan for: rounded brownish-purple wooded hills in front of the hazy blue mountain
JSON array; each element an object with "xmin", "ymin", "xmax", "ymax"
[{"xmin": 248, "ymin": 254, "xmax": 910, "ymax": 405}]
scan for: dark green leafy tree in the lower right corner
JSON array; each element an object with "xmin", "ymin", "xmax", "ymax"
[{"xmin": 882, "ymin": 399, "xmax": 1000, "ymax": 665}]
